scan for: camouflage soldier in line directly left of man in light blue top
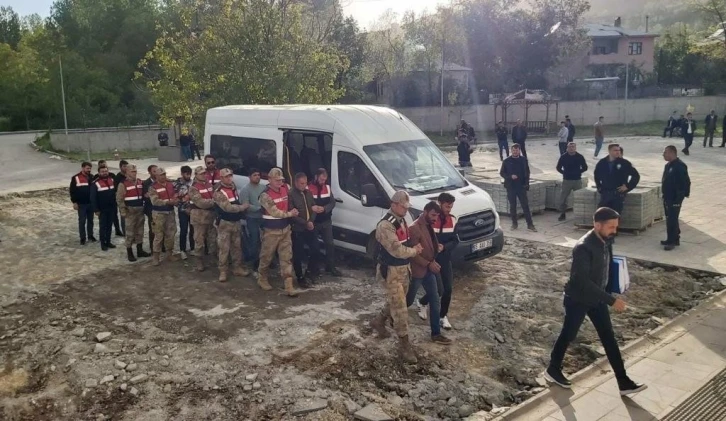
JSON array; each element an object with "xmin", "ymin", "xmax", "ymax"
[{"xmin": 214, "ymin": 168, "xmax": 250, "ymax": 282}]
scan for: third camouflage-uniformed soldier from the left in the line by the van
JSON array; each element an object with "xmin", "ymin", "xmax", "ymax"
[{"xmin": 189, "ymin": 166, "xmax": 217, "ymax": 272}]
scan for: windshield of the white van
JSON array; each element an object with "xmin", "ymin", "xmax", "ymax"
[{"xmin": 363, "ymin": 139, "xmax": 467, "ymax": 195}]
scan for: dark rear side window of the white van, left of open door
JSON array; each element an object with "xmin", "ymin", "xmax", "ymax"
[{"xmin": 209, "ymin": 135, "xmax": 277, "ymax": 179}]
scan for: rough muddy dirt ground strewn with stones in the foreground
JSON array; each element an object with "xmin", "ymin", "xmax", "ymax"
[{"xmin": 0, "ymin": 191, "xmax": 723, "ymax": 421}]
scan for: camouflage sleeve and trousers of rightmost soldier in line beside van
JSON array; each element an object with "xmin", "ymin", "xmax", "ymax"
[{"xmin": 258, "ymin": 192, "xmax": 297, "ymax": 297}]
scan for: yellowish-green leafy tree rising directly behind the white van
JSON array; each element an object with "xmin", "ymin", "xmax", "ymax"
[{"xmin": 136, "ymin": 0, "xmax": 346, "ymax": 127}]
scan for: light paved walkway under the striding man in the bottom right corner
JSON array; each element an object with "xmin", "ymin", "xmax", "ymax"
[{"xmin": 484, "ymin": 293, "xmax": 726, "ymax": 421}]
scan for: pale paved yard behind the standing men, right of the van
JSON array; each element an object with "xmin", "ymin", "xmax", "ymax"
[{"xmin": 449, "ymin": 137, "xmax": 726, "ymax": 273}]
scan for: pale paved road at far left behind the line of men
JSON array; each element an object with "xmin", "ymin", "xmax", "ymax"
[{"xmin": 0, "ymin": 134, "xmax": 203, "ymax": 194}]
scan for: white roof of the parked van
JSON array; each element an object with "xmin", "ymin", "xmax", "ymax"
[{"xmin": 206, "ymin": 105, "xmax": 426, "ymax": 146}]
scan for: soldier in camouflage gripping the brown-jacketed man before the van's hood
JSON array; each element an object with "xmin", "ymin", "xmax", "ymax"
[{"xmin": 371, "ymin": 191, "xmax": 422, "ymax": 363}]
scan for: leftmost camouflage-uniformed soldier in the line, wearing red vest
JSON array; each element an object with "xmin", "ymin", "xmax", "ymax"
[{"xmin": 116, "ymin": 165, "xmax": 151, "ymax": 262}]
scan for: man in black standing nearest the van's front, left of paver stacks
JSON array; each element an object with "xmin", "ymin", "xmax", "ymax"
[{"xmin": 499, "ymin": 145, "xmax": 537, "ymax": 232}]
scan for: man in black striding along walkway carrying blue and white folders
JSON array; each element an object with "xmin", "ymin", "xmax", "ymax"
[{"xmin": 545, "ymin": 208, "xmax": 647, "ymax": 396}]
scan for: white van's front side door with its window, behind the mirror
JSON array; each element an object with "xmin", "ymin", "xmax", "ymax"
[{"xmin": 331, "ymin": 144, "xmax": 388, "ymax": 253}]
